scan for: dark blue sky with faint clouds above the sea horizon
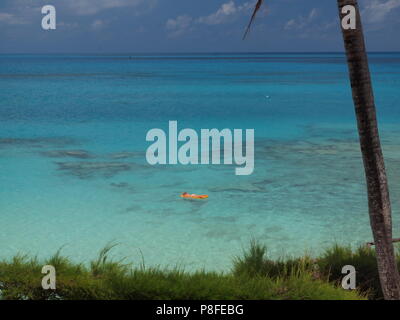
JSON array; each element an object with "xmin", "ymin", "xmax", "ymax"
[{"xmin": 0, "ymin": 0, "xmax": 400, "ymax": 53}]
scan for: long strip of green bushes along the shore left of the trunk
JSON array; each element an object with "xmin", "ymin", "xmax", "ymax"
[{"xmin": 0, "ymin": 241, "xmax": 392, "ymax": 300}]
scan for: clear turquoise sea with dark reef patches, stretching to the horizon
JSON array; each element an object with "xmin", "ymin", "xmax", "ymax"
[{"xmin": 0, "ymin": 53, "xmax": 400, "ymax": 270}]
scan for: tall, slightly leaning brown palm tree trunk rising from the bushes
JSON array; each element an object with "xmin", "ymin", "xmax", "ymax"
[{"xmin": 338, "ymin": 0, "xmax": 400, "ymax": 300}]
